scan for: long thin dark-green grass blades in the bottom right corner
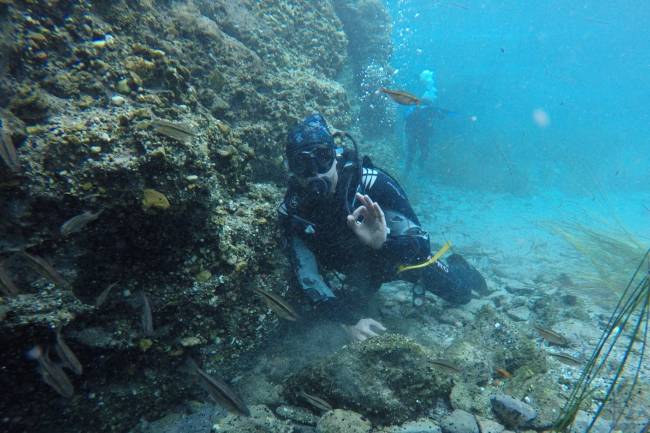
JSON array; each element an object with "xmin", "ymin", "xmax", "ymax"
[{"xmin": 554, "ymin": 249, "xmax": 650, "ymax": 433}]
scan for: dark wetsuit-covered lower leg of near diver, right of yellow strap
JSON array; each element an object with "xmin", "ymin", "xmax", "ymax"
[{"xmin": 421, "ymin": 254, "xmax": 487, "ymax": 304}]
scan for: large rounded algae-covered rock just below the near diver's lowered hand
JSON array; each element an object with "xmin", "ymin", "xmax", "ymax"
[{"xmin": 286, "ymin": 334, "xmax": 452, "ymax": 424}]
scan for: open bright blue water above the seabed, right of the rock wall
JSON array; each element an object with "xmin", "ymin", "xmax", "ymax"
[{"xmin": 387, "ymin": 0, "xmax": 650, "ymax": 195}]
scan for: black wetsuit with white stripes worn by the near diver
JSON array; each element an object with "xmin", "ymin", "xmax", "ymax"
[{"xmin": 278, "ymin": 156, "xmax": 484, "ymax": 314}]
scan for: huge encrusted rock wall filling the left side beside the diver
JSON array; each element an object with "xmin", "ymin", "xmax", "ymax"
[{"xmin": 0, "ymin": 0, "xmax": 374, "ymax": 432}]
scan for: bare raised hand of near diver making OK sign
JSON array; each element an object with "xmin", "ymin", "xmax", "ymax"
[{"xmin": 348, "ymin": 193, "xmax": 388, "ymax": 250}]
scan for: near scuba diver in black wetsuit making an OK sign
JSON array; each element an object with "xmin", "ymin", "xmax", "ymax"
[{"xmin": 278, "ymin": 113, "xmax": 486, "ymax": 336}]
